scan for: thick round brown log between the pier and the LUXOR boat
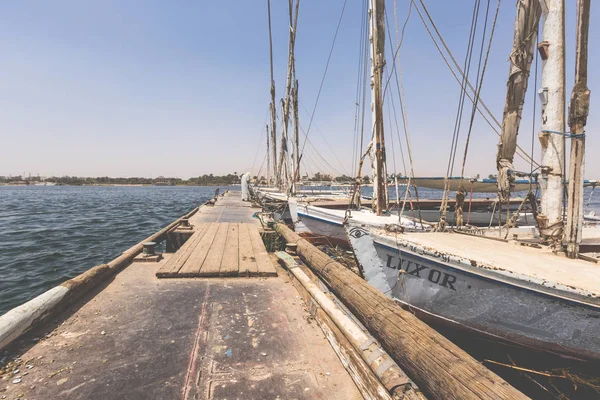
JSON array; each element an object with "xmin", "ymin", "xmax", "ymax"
[{"xmin": 275, "ymin": 223, "xmax": 527, "ymax": 400}]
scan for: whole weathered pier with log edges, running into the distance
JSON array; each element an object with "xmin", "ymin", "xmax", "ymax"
[{"xmin": 0, "ymin": 192, "xmax": 525, "ymax": 399}]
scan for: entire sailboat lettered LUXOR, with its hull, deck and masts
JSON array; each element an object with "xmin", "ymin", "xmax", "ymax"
[{"xmin": 345, "ymin": 0, "xmax": 600, "ymax": 361}]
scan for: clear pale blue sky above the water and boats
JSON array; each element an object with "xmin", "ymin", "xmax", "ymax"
[{"xmin": 0, "ymin": 0, "xmax": 600, "ymax": 178}]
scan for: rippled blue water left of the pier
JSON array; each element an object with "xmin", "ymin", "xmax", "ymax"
[{"xmin": 0, "ymin": 186, "xmax": 215, "ymax": 315}]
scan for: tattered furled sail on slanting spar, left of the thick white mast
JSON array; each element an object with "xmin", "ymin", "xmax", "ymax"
[{"xmin": 496, "ymin": 0, "xmax": 542, "ymax": 201}]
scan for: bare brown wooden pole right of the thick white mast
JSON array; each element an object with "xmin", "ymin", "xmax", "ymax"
[{"xmin": 565, "ymin": 0, "xmax": 591, "ymax": 258}]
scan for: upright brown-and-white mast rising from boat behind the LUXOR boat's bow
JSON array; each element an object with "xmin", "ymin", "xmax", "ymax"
[{"xmin": 369, "ymin": 0, "xmax": 388, "ymax": 215}]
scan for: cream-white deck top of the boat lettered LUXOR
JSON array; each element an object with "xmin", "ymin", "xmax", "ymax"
[{"xmin": 387, "ymin": 233, "xmax": 600, "ymax": 301}]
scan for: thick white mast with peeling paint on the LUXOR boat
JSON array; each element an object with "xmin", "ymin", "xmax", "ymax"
[{"xmin": 538, "ymin": 0, "xmax": 565, "ymax": 246}]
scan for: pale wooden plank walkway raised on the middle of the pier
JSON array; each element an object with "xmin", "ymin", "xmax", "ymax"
[{"xmin": 156, "ymin": 193, "xmax": 277, "ymax": 278}]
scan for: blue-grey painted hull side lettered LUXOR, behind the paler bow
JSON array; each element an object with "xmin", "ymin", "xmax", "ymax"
[{"xmin": 373, "ymin": 234, "xmax": 600, "ymax": 361}]
